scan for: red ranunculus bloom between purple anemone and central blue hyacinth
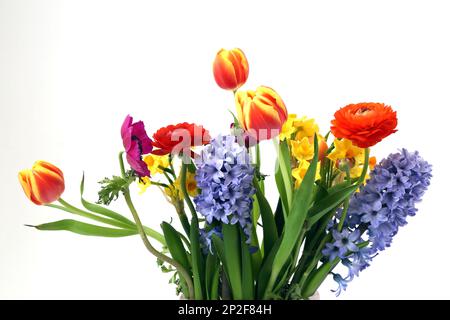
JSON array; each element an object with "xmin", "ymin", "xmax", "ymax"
[{"xmin": 152, "ymin": 122, "xmax": 211, "ymax": 155}]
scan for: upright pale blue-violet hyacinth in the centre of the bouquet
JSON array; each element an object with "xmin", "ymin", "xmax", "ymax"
[{"xmin": 194, "ymin": 135, "xmax": 255, "ymax": 242}]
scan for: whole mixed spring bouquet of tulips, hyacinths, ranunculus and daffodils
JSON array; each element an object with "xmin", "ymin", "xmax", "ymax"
[{"xmin": 19, "ymin": 49, "xmax": 431, "ymax": 300}]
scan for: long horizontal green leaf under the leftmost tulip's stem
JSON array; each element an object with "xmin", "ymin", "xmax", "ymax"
[{"xmin": 30, "ymin": 219, "xmax": 137, "ymax": 238}]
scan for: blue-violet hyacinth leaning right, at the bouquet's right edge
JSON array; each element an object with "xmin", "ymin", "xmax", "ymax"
[{"xmin": 322, "ymin": 149, "xmax": 431, "ymax": 292}]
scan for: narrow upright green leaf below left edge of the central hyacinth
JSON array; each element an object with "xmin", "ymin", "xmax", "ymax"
[{"xmin": 190, "ymin": 217, "xmax": 204, "ymax": 300}]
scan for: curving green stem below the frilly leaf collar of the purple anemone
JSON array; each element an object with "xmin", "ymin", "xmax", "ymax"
[{"xmin": 124, "ymin": 190, "xmax": 194, "ymax": 299}]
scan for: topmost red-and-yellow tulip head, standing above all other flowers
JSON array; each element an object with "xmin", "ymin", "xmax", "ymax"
[{"xmin": 213, "ymin": 48, "xmax": 248, "ymax": 90}]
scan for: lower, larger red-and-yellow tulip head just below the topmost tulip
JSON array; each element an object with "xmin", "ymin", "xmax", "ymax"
[{"xmin": 236, "ymin": 86, "xmax": 288, "ymax": 141}]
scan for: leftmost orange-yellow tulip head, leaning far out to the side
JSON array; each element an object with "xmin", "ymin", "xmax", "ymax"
[{"xmin": 19, "ymin": 161, "xmax": 64, "ymax": 205}]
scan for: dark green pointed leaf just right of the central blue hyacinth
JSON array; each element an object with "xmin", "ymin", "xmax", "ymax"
[{"xmin": 253, "ymin": 179, "xmax": 278, "ymax": 252}]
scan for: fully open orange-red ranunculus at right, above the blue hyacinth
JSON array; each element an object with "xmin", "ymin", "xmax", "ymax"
[{"xmin": 331, "ymin": 102, "xmax": 397, "ymax": 148}]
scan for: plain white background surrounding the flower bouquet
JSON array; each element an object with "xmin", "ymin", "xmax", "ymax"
[{"xmin": 0, "ymin": 0, "xmax": 450, "ymax": 299}]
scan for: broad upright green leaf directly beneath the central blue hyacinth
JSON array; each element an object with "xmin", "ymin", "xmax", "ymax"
[{"xmin": 222, "ymin": 224, "xmax": 243, "ymax": 300}]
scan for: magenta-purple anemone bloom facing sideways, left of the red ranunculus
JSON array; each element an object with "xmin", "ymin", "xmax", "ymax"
[{"xmin": 121, "ymin": 115, "xmax": 153, "ymax": 177}]
